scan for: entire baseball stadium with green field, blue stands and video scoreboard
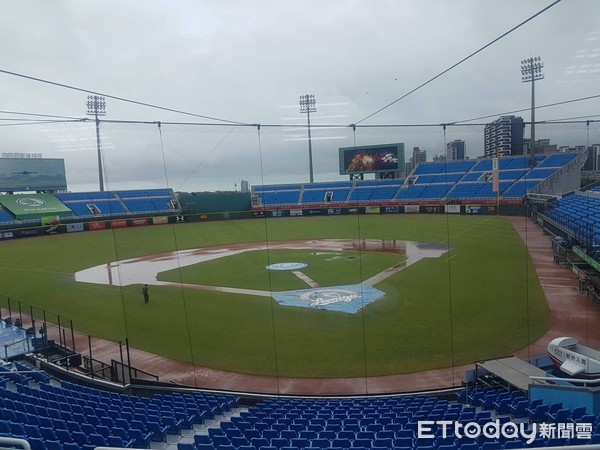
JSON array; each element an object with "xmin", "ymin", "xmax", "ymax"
[{"xmin": 0, "ymin": 116, "xmax": 600, "ymax": 450}]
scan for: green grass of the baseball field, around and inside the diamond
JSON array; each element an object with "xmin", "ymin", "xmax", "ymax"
[{"xmin": 0, "ymin": 215, "xmax": 549, "ymax": 377}]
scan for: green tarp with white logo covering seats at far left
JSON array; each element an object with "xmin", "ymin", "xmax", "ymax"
[{"xmin": 0, "ymin": 194, "xmax": 74, "ymax": 219}]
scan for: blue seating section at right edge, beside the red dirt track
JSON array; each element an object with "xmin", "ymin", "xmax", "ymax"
[{"xmin": 545, "ymin": 191, "xmax": 600, "ymax": 248}]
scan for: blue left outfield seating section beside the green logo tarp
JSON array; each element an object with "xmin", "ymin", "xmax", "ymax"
[{"xmin": 56, "ymin": 189, "xmax": 175, "ymax": 217}]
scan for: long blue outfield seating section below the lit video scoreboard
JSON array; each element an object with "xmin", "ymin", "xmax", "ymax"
[{"xmin": 253, "ymin": 153, "xmax": 577, "ymax": 206}]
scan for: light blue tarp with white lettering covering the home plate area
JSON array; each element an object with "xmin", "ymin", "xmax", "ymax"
[{"xmin": 273, "ymin": 284, "xmax": 385, "ymax": 314}]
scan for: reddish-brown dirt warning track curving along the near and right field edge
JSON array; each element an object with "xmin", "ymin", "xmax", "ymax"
[{"xmin": 77, "ymin": 217, "xmax": 600, "ymax": 395}]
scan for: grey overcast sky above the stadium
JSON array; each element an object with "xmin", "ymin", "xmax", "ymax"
[{"xmin": 0, "ymin": 0, "xmax": 600, "ymax": 191}]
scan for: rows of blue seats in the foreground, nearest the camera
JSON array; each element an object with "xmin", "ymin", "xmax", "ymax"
[{"xmin": 0, "ymin": 363, "xmax": 600, "ymax": 450}]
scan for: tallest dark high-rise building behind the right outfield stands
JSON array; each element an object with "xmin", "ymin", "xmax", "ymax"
[{"xmin": 484, "ymin": 116, "xmax": 525, "ymax": 157}]
